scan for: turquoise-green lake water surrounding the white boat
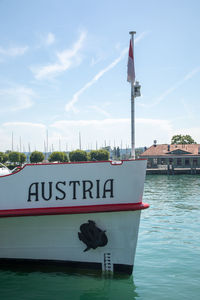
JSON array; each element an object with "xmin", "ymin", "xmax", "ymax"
[{"xmin": 0, "ymin": 175, "xmax": 200, "ymax": 300}]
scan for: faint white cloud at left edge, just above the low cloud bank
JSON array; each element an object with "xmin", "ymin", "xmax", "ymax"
[{"xmin": 0, "ymin": 86, "xmax": 35, "ymax": 113}]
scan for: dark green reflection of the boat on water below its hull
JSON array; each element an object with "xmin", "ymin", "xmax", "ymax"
[{"xmin": 0, "ymin": 270, "xmax": 138, "ymax": 300}]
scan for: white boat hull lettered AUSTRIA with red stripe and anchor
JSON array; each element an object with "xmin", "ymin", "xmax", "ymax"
[{"xmin": 0, "ymin": 159, "xmax": 148, "ymax": 274}]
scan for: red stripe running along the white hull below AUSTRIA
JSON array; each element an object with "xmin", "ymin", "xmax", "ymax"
[{"xmin": 0, "ymin": 202, "xmax": 149, "ymax": 217}]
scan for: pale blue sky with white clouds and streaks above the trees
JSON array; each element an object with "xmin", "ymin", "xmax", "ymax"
[{"xmin": 0, "ymin": 0, "xmax": 200, "ymax": 151}]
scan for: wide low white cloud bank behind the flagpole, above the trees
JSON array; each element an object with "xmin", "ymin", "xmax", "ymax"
[{"xmin": 51, "ymin": 118, "xmax": 172, "ymax": 148}]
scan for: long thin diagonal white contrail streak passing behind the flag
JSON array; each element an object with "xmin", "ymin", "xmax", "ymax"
[{"xmin": 65, "ymin": 32, "xmax": 146, "ymax": 112}]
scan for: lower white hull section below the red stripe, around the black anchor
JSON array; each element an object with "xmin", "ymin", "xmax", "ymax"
[{"xmin": 0, "ymin": 211, "xmax": 140, "ymax": 272}]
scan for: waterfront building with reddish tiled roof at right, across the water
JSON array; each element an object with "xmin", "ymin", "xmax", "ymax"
[{"xmin": 140, "ymin": 143, "xmax": 200, "ymax": 169}]
